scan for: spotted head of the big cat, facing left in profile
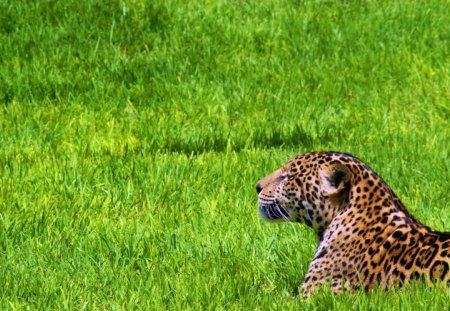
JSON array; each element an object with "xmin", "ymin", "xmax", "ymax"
[{"xmin": 256, "ymin": 153, "xmax": 352, "ymax": 231}]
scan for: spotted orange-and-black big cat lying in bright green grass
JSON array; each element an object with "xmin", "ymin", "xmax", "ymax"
[{"xmin": 256, "ymin": 151, "xmax": 450, "ymax": 297}]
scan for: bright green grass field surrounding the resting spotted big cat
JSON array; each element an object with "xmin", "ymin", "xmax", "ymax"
[{"xmin": 0, "ymin": 0, "xmax": 450, "ymax": 310}]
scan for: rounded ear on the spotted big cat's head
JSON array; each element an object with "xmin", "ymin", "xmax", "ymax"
[{"xmin": 319, "ymin": 163, "xmax": 352, "ymax": 196}]
